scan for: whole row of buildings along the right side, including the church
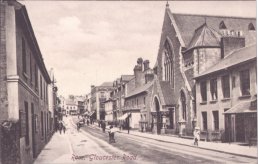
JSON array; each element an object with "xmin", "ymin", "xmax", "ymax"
[{"xmin": 87, "ymin": 4, "xmax": 257, "ymax": 145}]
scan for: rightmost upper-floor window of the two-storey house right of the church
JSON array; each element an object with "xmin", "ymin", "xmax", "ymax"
[{"xmin": 240, "ymin": 70, "xmax": 250, "ymax": 96}]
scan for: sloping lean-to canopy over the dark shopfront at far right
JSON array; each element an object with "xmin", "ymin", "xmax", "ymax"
[{"xmin": 224, "ymin": 100, "xmax": 257, "ymax": 114}]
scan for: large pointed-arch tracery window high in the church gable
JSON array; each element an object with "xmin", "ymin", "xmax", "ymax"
[{"xmin": 162, "ymin": 40, "xmax": 174, "ymax": 84}]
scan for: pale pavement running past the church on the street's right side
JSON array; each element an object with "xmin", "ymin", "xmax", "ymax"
[{"xmin": 91, "ymin": 123, "xmax": 258, "ymax": 158}]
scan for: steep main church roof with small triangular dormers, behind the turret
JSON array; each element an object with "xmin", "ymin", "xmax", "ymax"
[{"xmin": 171, "ymin": 13, "xmax": 256, "ymax": 47}]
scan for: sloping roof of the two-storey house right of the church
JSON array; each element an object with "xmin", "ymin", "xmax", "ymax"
[{"xmin": 195, "ymin": 44, "xmax": 256, "ymax": 78}]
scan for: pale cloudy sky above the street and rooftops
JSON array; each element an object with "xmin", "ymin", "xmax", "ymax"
[{"xmin": 21, "ymin": 1, "xmax": 256, "ymax": 96}]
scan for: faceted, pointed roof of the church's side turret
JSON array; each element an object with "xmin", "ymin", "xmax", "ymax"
[{"xmin": 188, "ymin": 23, "xmax": 221, "ymax": 49}]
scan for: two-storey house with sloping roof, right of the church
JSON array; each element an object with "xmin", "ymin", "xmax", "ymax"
[{"xmin": 195, "ymin": 44, "xmax": 257, "ymax": 142}]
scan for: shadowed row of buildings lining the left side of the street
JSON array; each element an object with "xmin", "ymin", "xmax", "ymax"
[{"xmin": 0, "ymin": 1, "xmax": 58, "ymax": 164}]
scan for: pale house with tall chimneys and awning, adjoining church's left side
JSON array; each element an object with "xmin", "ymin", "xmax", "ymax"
[{"xmin": 118, "ymin": 58, "xmax": 154, "ymax": 132}]
